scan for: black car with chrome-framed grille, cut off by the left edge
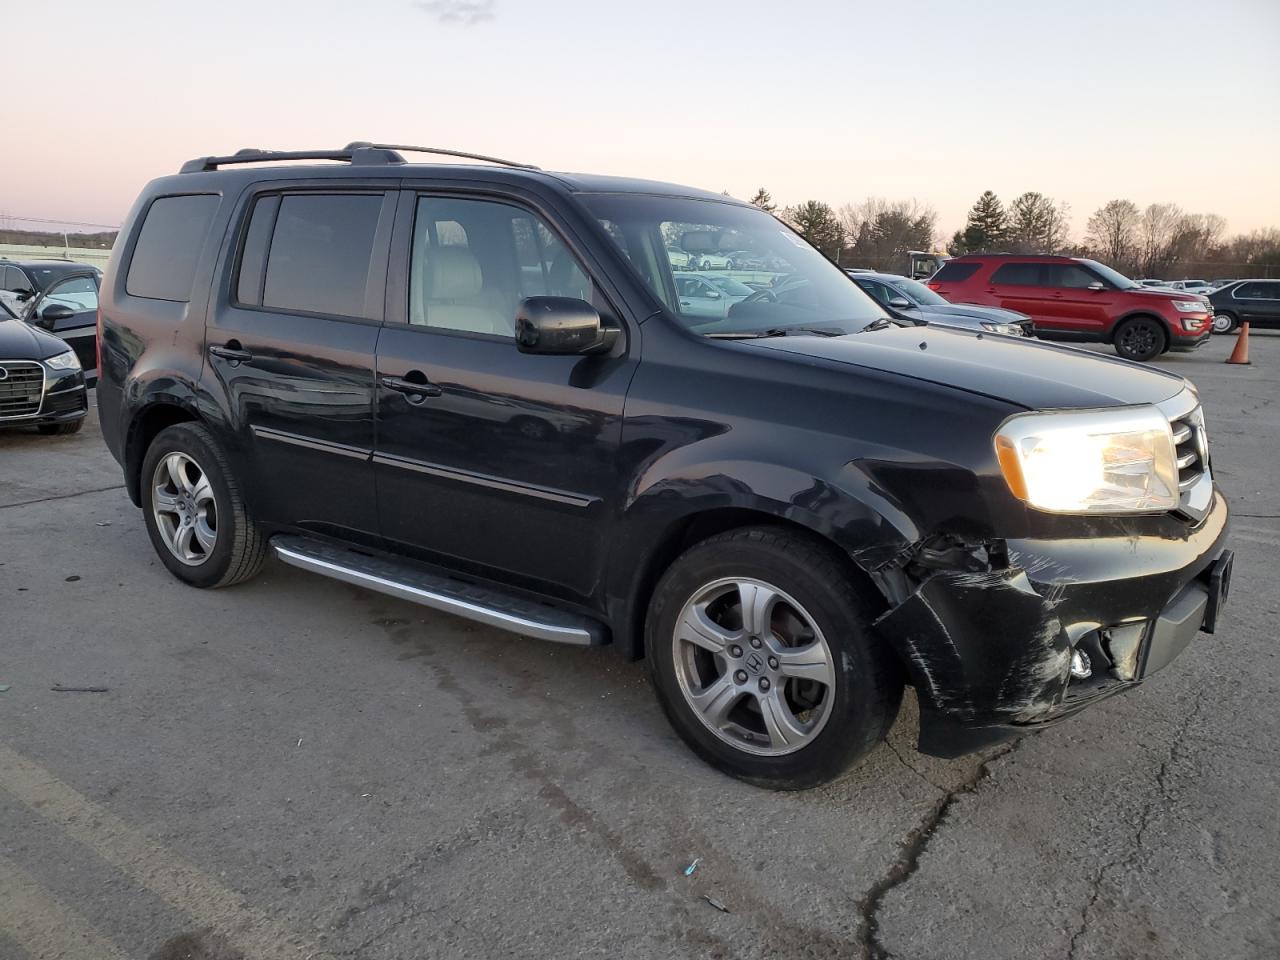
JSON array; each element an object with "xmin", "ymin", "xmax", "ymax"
[{"xmin": 0, "ymin": 295, "xmax": 88, "ymax": 434}]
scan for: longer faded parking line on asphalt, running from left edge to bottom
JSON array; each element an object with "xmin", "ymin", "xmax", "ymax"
[{"xmin": 0, "ymin": 745, "xmax": 329, "ymax": 960}]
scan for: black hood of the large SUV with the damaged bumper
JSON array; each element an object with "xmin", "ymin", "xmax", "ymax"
[{"xmin": 742, "ymin": 326, "xmax": 1187, "ymax": 410}]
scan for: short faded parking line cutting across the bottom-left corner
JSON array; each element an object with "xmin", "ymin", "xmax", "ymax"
[{"xmin": 0, "ymin": 856, "xmax": 128, "ymax": 960}]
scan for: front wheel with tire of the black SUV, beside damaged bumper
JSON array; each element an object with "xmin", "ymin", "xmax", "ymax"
[{"xmin": 645, "ymin": 527, "xmax": 902, "ymax": 790}]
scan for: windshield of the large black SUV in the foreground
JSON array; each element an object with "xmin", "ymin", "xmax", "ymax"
[{"xmin": 584, "ymin": 193, "xmax": 884, "ymax": 335}]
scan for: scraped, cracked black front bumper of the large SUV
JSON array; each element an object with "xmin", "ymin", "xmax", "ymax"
[{"xmin": 877, "ymin": 490, "xmax": 1231, "ymax": 756}]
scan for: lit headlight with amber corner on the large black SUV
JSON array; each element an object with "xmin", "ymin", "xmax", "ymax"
[{"xmin": 995, "ymin": 407, "xmax": 1179, "ymax": 513}]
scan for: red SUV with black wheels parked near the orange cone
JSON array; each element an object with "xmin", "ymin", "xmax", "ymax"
[{"xmin": 928, "ymin": 253, "xmax": 1212, "ymax": 361}]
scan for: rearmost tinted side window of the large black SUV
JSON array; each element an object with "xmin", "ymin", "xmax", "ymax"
[{"xmin": 124, "ymin": 193, "xmax": 220, "ymax": 303}]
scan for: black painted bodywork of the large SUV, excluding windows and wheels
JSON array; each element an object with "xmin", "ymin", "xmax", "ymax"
[{"xmin": 99, "ymin": 156, "xmax": 1226, "ymax": 753}]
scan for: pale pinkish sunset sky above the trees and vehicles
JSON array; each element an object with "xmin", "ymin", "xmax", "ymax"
[{"xmin": 0, "ymin": 0, "xmax": 1280, "ymax": 239}]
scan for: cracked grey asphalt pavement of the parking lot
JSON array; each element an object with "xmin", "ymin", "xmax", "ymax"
[{"xmin": 0, "ymin": 334, "xmax": 1280, "ymax": 960}]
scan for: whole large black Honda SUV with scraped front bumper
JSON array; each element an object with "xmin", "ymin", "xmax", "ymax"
[{"xmin": 99, "ymin": 143, "xmax": 1231, "ymax": 787}]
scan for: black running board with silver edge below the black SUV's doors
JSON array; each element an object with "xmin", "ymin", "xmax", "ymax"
[{"xmin": 271, "ymin": 534, "xmax": 608, "ymax": 646}]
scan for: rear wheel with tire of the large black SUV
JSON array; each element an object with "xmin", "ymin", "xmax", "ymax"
[{"xmin": 142, "ymin": 424, "xmax": 266, "ymax": 588}]
